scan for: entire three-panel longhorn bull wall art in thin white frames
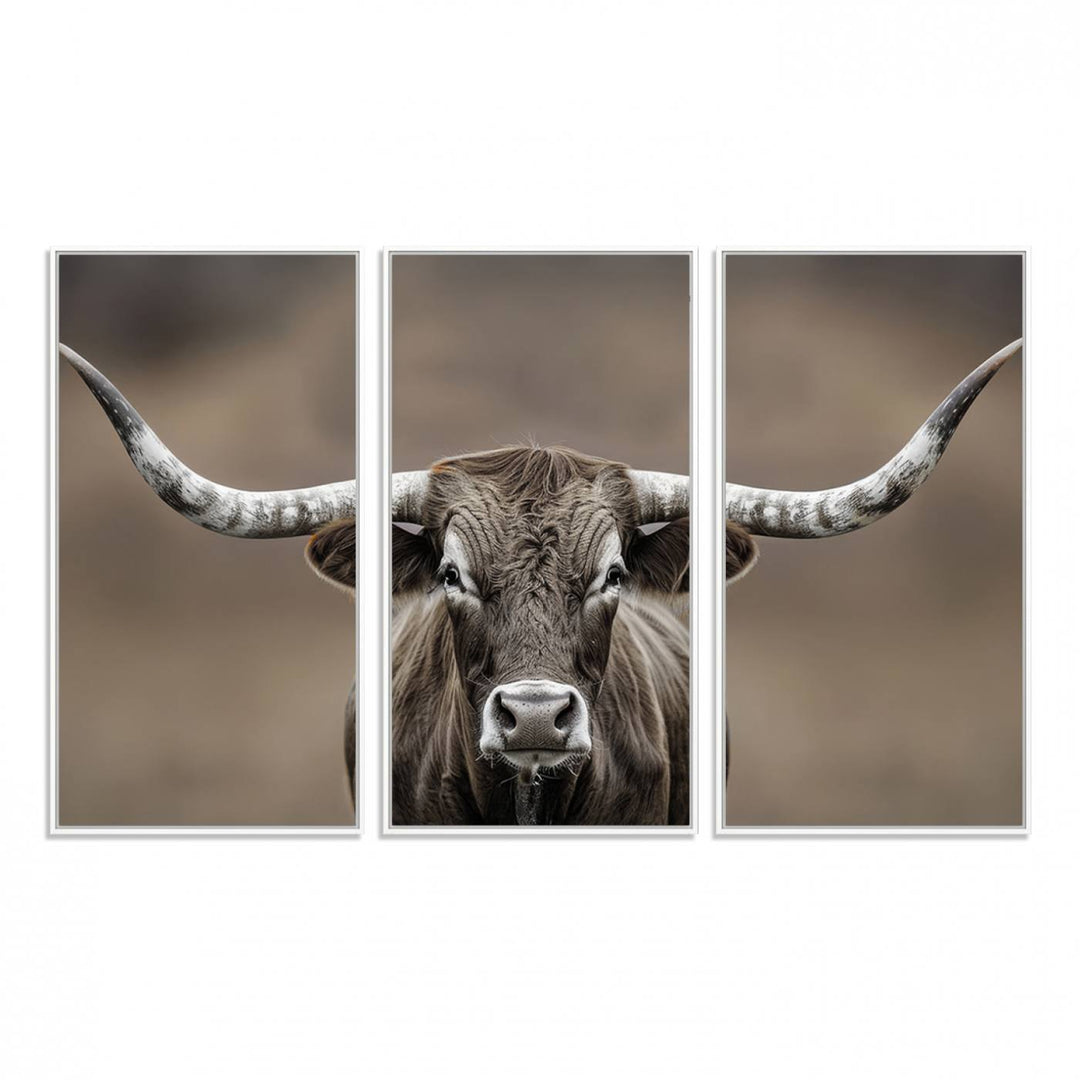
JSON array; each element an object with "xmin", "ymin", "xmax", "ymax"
[{"xmin": 49, "ymin": 249, "xmax": 1028, "ymax": 836}]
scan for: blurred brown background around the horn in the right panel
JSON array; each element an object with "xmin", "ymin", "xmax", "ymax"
[{"xmin": 725, "ymin": 255, "xmax": 1026, "ymax": 825}]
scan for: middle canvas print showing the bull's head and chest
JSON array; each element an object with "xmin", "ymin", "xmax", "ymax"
[{"xmin": 388, "ymin": 252, "xmax": 692, "ymax": 827}]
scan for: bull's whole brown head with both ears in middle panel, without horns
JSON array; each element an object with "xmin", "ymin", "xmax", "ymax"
[{"xmin": 394, "ymin": 448, "xmax": 689, "ymax": 782}]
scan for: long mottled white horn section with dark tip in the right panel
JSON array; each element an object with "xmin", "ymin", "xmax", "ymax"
[{"xmin": 725, "ymin": 338, "xmax": 1024, "ymax": 540}]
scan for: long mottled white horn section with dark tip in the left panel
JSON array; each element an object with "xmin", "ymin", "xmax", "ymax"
[{"xmin": 59, "ymin": 345, "xmax": 356, "ymax": 540}]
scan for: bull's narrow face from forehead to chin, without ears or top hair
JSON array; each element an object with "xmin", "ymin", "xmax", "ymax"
[{"xmin": 437, "ymin": 492, "xmax": 626, "ymax": 771}]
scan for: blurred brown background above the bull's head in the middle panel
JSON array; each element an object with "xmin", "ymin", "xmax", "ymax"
[{"xmin": 391, "ymin": 254, "xmax": 690, "ymax": 473}]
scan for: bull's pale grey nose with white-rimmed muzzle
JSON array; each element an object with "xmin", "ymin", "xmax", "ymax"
[{"xmin": 481, "ymin": 679, "xmax": 591, "ymax": 754}]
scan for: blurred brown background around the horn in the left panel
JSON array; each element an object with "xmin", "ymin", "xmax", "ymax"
[{"xmin": 57, "ymin": 255, "xmax": 355, "ymax": 826}]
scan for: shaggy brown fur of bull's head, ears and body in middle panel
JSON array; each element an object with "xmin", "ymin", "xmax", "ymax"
[{"xmin": 392, "ymin": 447, "xmax": 690, "ymax": 825}]
